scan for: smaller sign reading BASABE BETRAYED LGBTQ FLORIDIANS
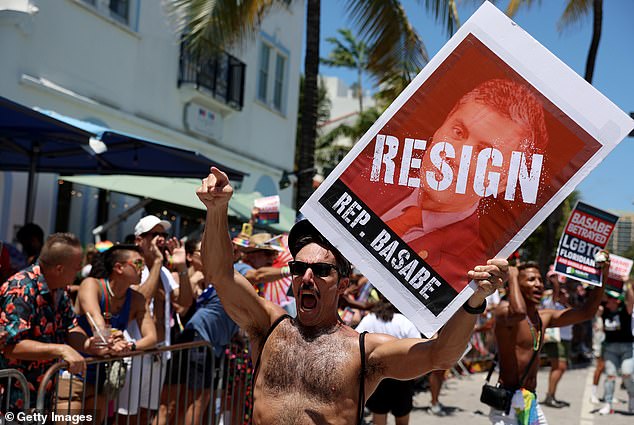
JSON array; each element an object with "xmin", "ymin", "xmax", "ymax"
[{"xmin": 555, "ymin": 202, "xmax": 619, "ymax": 286}]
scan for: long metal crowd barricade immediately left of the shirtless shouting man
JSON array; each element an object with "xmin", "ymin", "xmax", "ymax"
[{"xmin": 35, "ymin": 341, "xmax": 252, "ymax": 425}]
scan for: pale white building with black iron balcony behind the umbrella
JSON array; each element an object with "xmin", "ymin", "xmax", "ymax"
[{"xmin": 0, "ymin": 0, "xmax": 305, "ymax": 241}]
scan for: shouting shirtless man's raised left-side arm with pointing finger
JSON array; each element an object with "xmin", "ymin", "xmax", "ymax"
[{"xmin": 196, "ymin": 167, "xmax": 276, "ymax": 332}]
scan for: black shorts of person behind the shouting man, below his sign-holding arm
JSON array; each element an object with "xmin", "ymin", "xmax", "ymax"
[{"xmin": 365, "ymin": 379, "xmax": 414, "ymax": 418}]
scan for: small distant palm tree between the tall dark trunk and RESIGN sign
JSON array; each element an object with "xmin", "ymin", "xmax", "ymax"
[{"xmin": 321, "ymin": 29, "xmax": 368, "ymax": 114}]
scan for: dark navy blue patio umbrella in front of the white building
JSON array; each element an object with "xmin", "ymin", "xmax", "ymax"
[{"xmin": 0, "ymin": 97, "xmax": 245, "ymax": 222}]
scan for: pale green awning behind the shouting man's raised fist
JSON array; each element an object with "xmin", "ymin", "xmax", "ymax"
[{"xmin": 60, "ymin": 175, "xmax": 295, "ymax": 232}]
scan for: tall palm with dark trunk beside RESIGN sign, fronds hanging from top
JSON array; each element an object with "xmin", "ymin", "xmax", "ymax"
[{"xmin": 167, "ymin": 0, "xmax": 458, "ymax": 209}]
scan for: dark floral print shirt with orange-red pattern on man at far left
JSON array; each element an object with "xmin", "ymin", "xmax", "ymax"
[{"xmin": 0, "ymin": 264, "xmax": 77, "ymax": 410}]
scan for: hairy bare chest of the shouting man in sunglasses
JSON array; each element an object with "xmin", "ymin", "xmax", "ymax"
[{"xmin": 260, "ymin": 322, "xmax": 361, "ymax": 403}]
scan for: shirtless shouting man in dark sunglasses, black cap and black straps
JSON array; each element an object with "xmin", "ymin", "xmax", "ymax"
[{"xmin": 196, "ymin": 168, "xmax": 508, "ymax": 424}]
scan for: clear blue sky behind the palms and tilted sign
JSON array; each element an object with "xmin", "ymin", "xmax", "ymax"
[{"xmin": 320, "ymin": 0, "xmax": 634, "ymax": 211}]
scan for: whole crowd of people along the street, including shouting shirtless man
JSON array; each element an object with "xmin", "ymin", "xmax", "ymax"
[{"xmin": 0, "ymin": 169, "xmax": 634, "ymax": 425}]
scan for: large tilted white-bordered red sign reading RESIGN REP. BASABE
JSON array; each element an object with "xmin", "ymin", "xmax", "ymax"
[{"xmin": 302, "ymin": 3, "xmax": 634, "ymax": 336}]
